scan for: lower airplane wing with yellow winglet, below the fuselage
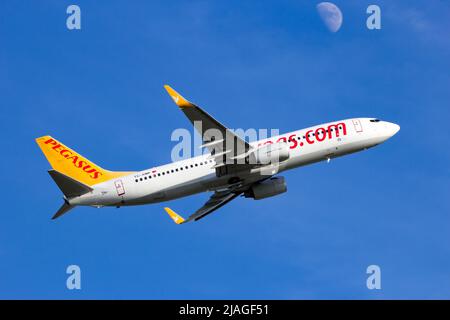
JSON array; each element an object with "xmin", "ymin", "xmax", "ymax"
[{"xmin": 164, "ymin": 190, "xmax": 241, "ymax": 224}]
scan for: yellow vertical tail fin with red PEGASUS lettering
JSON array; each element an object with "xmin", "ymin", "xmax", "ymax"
[{"xmin": 36, "ymin": 136, "xmax": 131, "ymax": 186}]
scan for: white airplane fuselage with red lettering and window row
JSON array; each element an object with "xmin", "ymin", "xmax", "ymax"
[{"xmin": 69, "ymin": 118, "xmax": 400, "ymax": 207}]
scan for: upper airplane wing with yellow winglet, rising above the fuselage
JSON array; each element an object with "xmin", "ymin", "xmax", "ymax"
[{"xmin": 164, "ymin": 85, "xmax": 252, "ymax": 176}]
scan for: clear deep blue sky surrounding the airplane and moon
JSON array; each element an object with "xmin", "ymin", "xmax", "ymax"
[{"xmin": 0, "ymin": 0, "xmax": 450, "ymax": 299}]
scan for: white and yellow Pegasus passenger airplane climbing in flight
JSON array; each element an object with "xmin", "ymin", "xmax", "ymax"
[{"xmin": 36, "ymin": 85, "xmax": 400, "ymax": 224}]
